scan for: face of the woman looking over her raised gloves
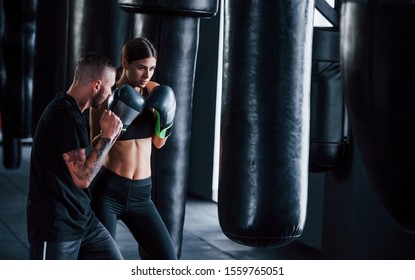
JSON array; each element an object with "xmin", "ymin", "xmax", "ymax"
[{"xmin": 123, "ymin": 57, "xmax": 157, "ymax": 88}]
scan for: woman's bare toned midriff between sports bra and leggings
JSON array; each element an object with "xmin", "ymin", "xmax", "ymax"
[{"xmin": 104, "ymin": 137, "xmax": 152, "ymax": 180}]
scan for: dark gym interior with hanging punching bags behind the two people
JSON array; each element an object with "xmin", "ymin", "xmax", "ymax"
[{"xmin": 0, "ymin": 0, "xmax": 415, "ymax": 260}]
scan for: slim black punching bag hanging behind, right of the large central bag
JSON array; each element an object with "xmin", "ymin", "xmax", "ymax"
[{"xmin": 309, "ymin": 0, "xmax": 348, "ymax": 172}]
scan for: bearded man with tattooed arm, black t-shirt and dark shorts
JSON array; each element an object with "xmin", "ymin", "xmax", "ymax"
[{"xmin": 27, "ymin": 53, "xmax": 122, "ymax": 260}]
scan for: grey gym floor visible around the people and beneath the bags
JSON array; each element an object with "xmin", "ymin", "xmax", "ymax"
[{"xmin": 0, "ymin": 143, "xmax": 320, "ymax": 260}]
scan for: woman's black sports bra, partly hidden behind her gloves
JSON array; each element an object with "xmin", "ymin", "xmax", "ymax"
[{"xmin": 117, "ymin": 88, "xmax": 156, "ymax": 141}]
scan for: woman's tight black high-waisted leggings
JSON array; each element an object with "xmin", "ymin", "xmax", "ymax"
[{"xmin": 92, "ymin": 167, "xmax": 177, "ymax": 260}]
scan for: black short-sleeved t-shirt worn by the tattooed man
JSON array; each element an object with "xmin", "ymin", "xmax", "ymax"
[{"xmin": 27, "ymin": 93, "xmax": 94, "ymax": 242}]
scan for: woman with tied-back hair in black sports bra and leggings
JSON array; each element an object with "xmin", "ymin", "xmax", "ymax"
[{"xmin": 90, "ymin": 38, "xmax": 177, "ymax": 259}]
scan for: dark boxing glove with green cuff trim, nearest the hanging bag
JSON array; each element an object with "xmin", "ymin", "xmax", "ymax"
[{"xmin": 146, "ymin": 85, "xmax": 176, "ymax": 138}]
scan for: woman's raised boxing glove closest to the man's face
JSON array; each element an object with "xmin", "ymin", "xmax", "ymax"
[{"xmin": 108, "ymin": 85, "xmax": 146, "ymax": 132}]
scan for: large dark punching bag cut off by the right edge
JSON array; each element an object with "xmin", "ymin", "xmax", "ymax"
[{"xmin": 340, "ymin": 0, "xmax": 415, "ymax": 232}]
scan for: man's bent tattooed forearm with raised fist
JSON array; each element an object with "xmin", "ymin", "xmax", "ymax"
[{"xmin": 62, "ymin": 111, "xmax": 122, "ymax": 189}]
